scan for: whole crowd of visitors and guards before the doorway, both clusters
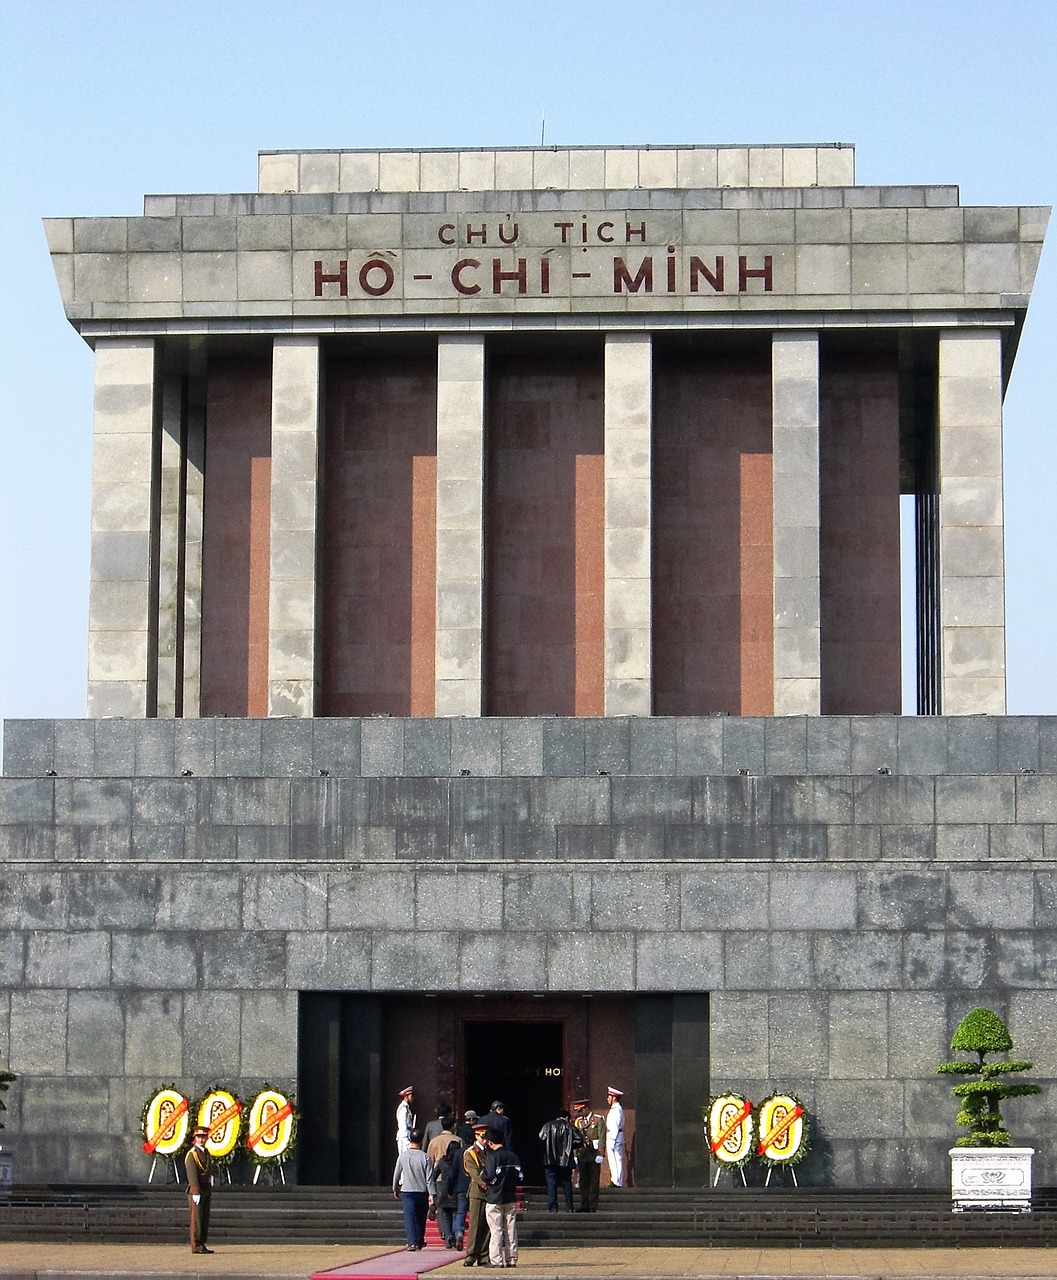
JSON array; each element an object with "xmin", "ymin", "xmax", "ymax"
[{"xmin": 393, "ymin": 1085, "xmax": 626, "ymax": 1267}]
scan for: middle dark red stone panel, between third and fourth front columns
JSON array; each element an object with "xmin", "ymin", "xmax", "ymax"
[{"xmin": 485, "ymin": 352, "xmax": 605, "ymax": 716}]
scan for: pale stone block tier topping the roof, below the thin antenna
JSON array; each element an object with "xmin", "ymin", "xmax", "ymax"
[{"xmin": 257, "ymin": 142, "xmax": 855, "ymax": 192}]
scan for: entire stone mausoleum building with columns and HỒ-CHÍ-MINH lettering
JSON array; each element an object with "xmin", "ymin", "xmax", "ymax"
[{"xmin": 0, "ymin": 145, "xmax": 1057, "ymax": 1187}]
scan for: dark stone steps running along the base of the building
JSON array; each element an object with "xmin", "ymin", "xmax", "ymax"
[{"xmin": 0, "ymin": 1185, "xmax": 1057, "ymax": 1248}]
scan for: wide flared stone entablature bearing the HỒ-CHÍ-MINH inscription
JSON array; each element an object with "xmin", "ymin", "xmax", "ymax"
[{"xmin": 46, "ymin": 188, "xmax": 1048, "ymax": 335}]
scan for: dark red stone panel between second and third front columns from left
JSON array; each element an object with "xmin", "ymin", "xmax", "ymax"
[{"xmin": 320, "ymin": 352, "xmax": 436, "ymax": 716}]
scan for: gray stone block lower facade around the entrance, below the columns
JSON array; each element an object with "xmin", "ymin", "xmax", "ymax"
[{"xmin": 0, "ymin": 717, "xmax": 1057, "ymax": 1187}]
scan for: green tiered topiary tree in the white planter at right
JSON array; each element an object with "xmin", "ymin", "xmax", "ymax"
[{"xmin": 937, "ymin": 1009, "xmax": 1042, "ymax": 1147}]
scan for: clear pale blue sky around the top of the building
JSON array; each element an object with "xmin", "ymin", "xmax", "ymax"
[{"xmin": 0, "ymin": 0, "xmax": 1057, "ymax": 718}]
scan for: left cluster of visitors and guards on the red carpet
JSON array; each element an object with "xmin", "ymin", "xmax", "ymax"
[{"xmin": 393, "ymin": 1085, "xmax": 525, "ymax": 1267}]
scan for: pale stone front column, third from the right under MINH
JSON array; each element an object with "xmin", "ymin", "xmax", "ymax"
[{"xmin": 605, "ymin": 333, "xmax": 653, "ymax": 716}]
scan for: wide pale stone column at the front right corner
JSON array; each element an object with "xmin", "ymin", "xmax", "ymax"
[{"xmin": 938, "ymin": 329, "xmax": 1006, "ymax": 716}]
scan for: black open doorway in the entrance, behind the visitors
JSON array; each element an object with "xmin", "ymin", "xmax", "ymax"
[{"xmin": 463, "ymin": 1021, "xmax": 566, "ymax": 1187}]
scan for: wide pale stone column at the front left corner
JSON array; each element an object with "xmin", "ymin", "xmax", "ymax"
[{"xmin": 88, "ymin": 338, "xmax": 157, "ymax": 718}]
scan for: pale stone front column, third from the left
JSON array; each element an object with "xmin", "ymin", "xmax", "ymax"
[{"xmin": 435, "ymin": 334, "xmax": 485, "ymax": 716}]
